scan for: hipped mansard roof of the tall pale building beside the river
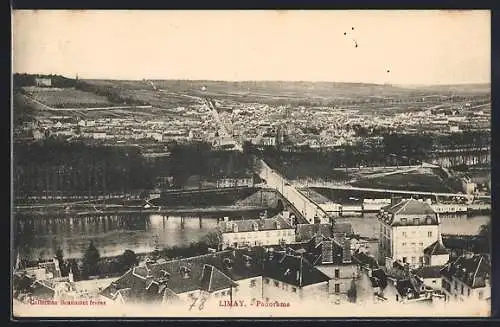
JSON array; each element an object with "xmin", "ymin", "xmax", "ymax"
[{"xmin": 377, "ymin": 199, "xmax": 439, "ymax": 226}]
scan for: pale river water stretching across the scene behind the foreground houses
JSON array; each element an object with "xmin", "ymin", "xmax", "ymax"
[{"xmin": 14, "ymin": 213, "xmax": 490, "ymax": 260}]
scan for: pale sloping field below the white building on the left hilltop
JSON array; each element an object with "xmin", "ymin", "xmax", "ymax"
[{"xmin": 28, "ymin": 88, "xmax": 112, "ymax": 108}]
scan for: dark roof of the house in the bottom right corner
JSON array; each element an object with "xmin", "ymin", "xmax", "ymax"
[{"xmin": 441, "ymin": 254, "xmax": 491, "ymax": 288}]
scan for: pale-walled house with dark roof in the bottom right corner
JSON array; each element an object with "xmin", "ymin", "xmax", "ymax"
[{"xmin": 441, "ymin": 252, "xmax": 491, "ymax": 301}]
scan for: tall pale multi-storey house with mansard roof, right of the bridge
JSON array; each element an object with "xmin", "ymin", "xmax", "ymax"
[{"xmin": 377, "ymin": 199, "xmax": 441, "ymax": 267}]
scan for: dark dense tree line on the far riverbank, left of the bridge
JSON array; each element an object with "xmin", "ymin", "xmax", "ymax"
[{"xmin": 13, "ymin": 139, "xmax": 253, "ymax": 196}]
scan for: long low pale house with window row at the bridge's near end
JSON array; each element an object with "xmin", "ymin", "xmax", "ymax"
[{"xmin": 218, "ymin": 215, "xmax": 295, "ymax": 249}]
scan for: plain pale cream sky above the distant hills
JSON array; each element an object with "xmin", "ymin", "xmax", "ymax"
[{"xmin": 12, "ymin": 10, "xmax": 491, "ymax": 84}]
